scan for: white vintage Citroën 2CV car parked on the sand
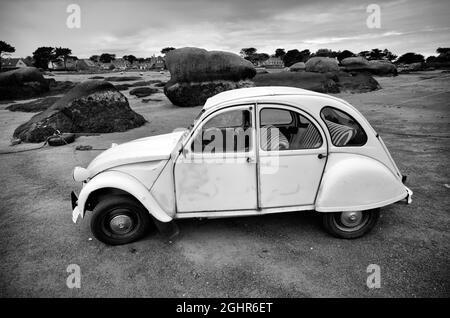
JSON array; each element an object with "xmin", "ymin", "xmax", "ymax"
[{"xmin": 71, "ymin": 87, "xmax": 412, "ymax": 245}]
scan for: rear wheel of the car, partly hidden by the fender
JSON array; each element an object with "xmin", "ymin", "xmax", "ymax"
[{"xmin": 322, "ymin": 209, "xmax": 380, "ymax": 239}]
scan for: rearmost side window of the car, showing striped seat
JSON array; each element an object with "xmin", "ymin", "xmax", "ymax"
[{"xmin": 320, "ymin": 106, "xmax": 367, "ymax": 147}]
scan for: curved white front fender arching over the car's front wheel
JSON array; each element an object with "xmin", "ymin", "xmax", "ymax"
[{"xmin": 77, "ymin": 170, "xmax": 172, "ymax": 222}]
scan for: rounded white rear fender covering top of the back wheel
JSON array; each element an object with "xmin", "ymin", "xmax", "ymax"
[{"xmin": 316, "ymin": 153, "xmax": 409, "ymax": 212}]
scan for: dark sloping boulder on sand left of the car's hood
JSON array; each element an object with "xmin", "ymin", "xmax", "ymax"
[{"xmin": 14, "ymin": 81, "xmax": 145, "ymax": 142}]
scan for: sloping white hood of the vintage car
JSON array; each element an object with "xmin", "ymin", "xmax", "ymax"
[{"xmin": 87, "ymin": 132, "xmax": 183, "ymax": 177}]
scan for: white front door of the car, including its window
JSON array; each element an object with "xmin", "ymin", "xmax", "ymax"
[{"xmin": 175, "ymin": 105, "xmax": 257, "ymax": 213}]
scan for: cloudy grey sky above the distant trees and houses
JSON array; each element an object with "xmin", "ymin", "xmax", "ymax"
[{"xmin": 0, "ymin": 0, "xmax": 450, "ymax": 57}]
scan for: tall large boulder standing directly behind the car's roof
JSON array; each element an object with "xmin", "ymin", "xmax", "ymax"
[{"xmin": 164, "ymin": 47, "xmax": 256, "ymax": 106}]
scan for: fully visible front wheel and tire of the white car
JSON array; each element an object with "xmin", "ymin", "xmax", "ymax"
[{"xmin": 91, "ymin": 196, "xmax": 151, "ymax": 245}]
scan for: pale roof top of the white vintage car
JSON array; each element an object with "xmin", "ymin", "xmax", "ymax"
[{"xmin": 203, "ymin": 86, "xmax": 338, "ymax": 110}]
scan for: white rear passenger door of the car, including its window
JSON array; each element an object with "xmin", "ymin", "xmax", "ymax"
[{"xmin": 256, "ymin": 104, "xmax": 327, "ymax": 209}]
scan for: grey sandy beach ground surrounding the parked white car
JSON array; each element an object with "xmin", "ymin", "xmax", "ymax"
[{"xmin": 0, "ymin": 71, "xmax": 450, "ymax": 297}]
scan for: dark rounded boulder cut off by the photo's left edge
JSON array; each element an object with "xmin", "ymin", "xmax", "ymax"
[{"xmin": 0, "ymin": 67, "xmax": 49, "ymax": 100}]
